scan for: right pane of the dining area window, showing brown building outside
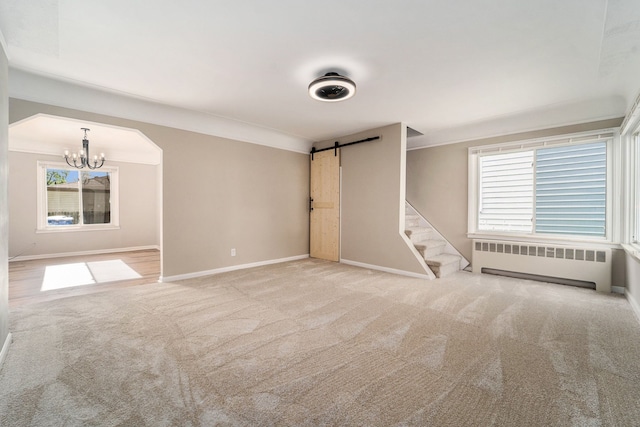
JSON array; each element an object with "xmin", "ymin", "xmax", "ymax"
[{"xmin": 82, "ymin": 172, "xmax": 111, "ymax": 224}]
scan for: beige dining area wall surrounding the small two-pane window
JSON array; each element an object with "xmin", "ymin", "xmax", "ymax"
[{"xmin": 9, "ymin": 151, "xmax": 160, "ymax": 257}]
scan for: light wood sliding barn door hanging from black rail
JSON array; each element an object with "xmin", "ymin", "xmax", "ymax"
[{"xmin": 309, "ymin": 149, "xmax": 340, "ymax": 261}]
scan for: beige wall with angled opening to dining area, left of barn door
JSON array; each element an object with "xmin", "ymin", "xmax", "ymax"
[{"xmin": 9, "ymin": 99, "xmax": 309, "ymax": 277}]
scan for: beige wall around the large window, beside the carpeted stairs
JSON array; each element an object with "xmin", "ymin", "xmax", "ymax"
[{"xmin": 407, "ymin": 119, "xmax": 624, "ymax": 286}]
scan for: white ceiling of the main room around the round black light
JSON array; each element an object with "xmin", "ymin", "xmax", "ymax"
[{"xmin": 0, "ymin": 0, "xmax": 640, "ymax": 151}]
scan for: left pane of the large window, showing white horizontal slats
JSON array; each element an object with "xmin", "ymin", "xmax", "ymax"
[{"xmin": 478, "ymin": 151, "xmax": 533, "ymax": 233}]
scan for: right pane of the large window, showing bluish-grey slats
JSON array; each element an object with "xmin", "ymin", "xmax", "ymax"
[{"xmin": 536, "ymin": 142, "xmax": 607, "ymax": 237}]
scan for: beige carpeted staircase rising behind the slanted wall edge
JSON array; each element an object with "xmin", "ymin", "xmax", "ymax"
[{"xmin": 404, "ymin": 205, "xmax": 465, "ymax": 278}]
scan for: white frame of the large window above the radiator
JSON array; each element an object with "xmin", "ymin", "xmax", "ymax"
[{"xmin": 467, "ymin": 128, "xmax": 621, "ymax": 246}]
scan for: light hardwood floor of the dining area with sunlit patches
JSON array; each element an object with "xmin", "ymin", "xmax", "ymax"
[{"xmin": 9, "ymin": 250, "xmax": 160, "ymax": 308}]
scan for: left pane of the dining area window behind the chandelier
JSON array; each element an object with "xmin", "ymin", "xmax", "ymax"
[{"xmin": 46, "ymin": 169, "xmax": 80, "ymax": 226}]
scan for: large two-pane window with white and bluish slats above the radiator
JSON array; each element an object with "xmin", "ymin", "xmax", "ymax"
[{"xmin": 470, "ymin": 135, "xmax": 612, "ymax": 239}]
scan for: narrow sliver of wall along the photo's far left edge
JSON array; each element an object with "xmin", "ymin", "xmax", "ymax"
[{"xmin": 0, "ymin": 39, "xmax": 9, "ymax": 362}]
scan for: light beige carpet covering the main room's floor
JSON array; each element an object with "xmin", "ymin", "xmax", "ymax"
[{"xmin": 0, "ymin": 259, "xmax": 640, "ymax": 426}]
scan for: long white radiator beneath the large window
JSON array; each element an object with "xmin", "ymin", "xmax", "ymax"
[{"xmin": 471, "ymin": 240, "xmax": 611, "ymax": 292}]
